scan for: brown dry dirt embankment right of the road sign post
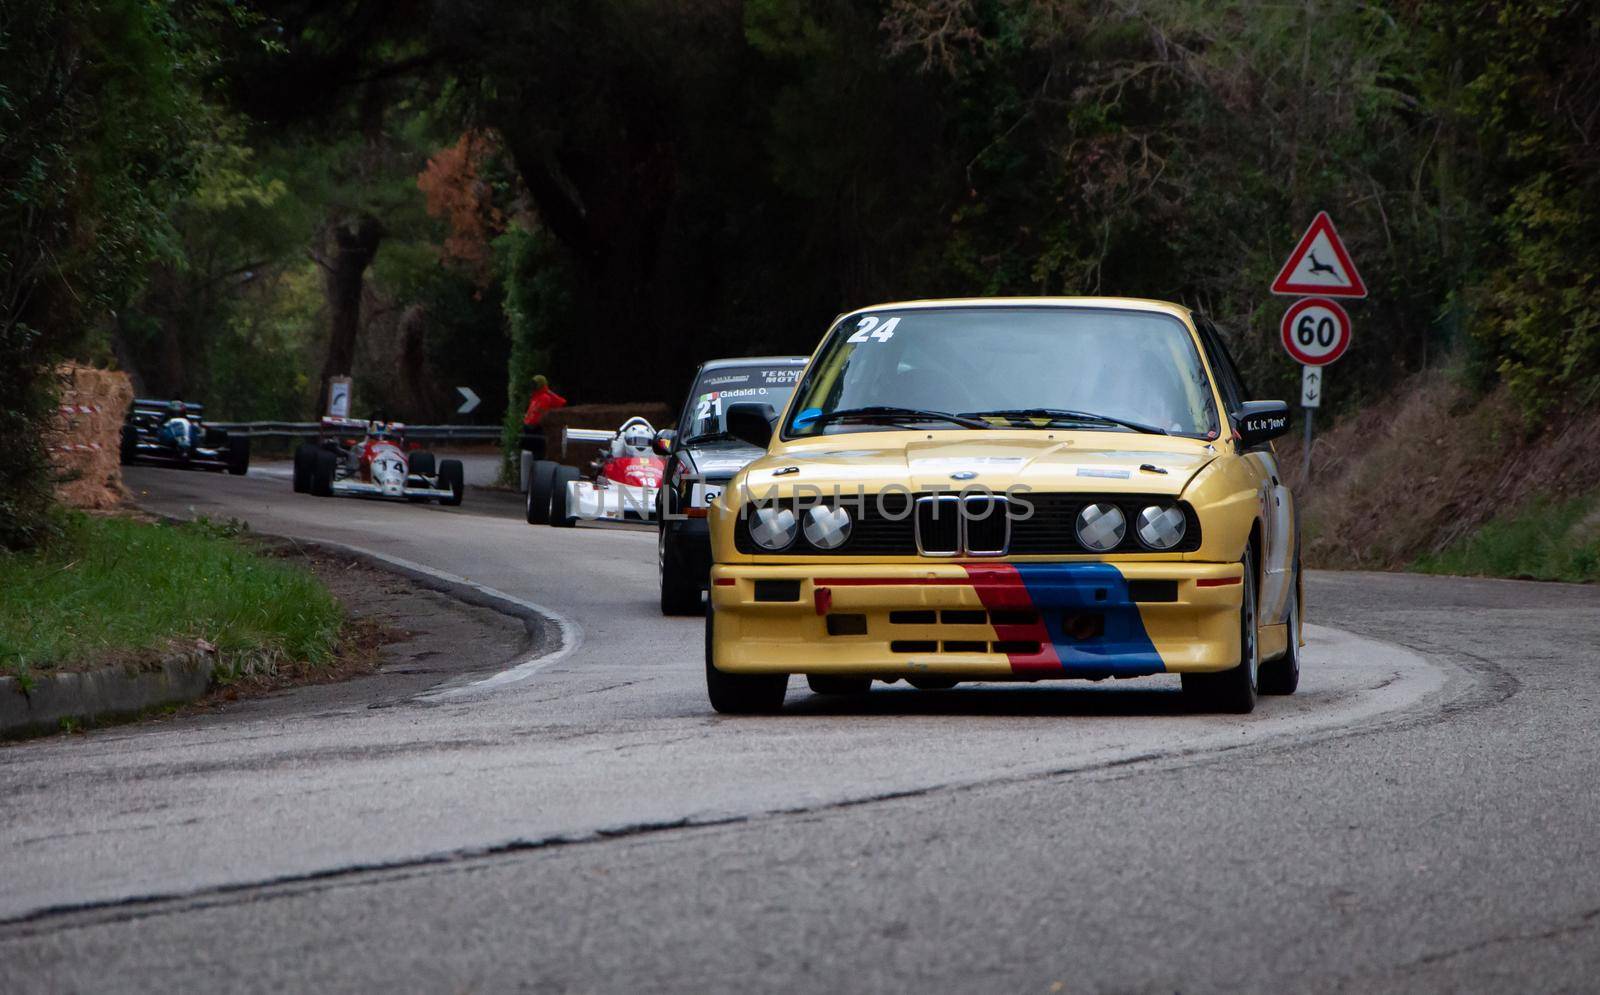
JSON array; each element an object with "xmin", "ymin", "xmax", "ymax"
[{"xmin": 1278, "ymin": 373, "xmax": 1600, "ymax": 569}]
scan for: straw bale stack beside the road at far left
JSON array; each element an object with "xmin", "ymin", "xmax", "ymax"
[{"xmin": 46, "ymin": 365, "xmax": 133, "ymax": 509}]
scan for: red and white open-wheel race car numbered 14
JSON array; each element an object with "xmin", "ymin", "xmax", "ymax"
[{"xmin": 294, "ymin": 418, "xmax": 466, "ymax": 505}]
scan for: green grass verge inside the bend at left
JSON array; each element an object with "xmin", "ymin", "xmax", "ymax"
[{"xmin": 0, "ymin": 513, "xmax": 344, "ymax": 680}]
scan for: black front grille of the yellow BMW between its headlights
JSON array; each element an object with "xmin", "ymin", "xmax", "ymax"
[{"xmin": 734, "ymin": 491, "xmax": 1200, "ymax": 557}]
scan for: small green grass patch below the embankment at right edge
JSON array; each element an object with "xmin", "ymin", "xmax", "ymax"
[{"xmin": 1413, "ymin": 498, "xmax": 1600, "ymax": 582}]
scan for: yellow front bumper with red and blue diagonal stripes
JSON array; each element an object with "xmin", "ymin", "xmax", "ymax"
[{"xmin": 710, "ymin": 561, "xmax": 1243, "ymax": 680}]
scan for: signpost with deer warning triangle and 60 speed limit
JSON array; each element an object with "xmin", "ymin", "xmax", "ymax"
[{"xmin": 1272, "ymin": 211, "xmax": 1366, "ymax": 480}]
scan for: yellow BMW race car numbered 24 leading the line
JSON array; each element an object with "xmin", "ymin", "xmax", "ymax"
[{"xmin": 706, "ymin": 298, "xmax": 1301, "ymax": 712}]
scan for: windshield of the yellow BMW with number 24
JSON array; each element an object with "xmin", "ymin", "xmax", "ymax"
[{"xmin": 784, "ymin": 306, "xmax": 1218, "ymax": 438}]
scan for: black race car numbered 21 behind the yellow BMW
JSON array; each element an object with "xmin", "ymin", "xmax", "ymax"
[{"xmin": 656, "ymin": 355, "xmax": 806, "ymax": 614}]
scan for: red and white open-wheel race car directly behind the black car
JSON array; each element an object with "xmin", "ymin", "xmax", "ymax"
[{"xmin": 528, "ymin": 418, "xmax": 667, "ymax": 526}]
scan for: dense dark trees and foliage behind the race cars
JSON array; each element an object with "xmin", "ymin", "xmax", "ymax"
[{"xmin": 0, "ymin": 0, "xmax": 1600, "ymax": 553}]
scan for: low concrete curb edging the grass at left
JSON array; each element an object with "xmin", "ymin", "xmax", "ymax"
[{"xmin": 0, "ymin": 649, "xmax": 216, "ymax": 739}]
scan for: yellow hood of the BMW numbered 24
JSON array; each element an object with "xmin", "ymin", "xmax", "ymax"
[{"xmin": 744, "ymin": 429, "xmax": 1219, "ymax": 496}]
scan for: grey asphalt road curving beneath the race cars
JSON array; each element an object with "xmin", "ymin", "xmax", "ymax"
[{"xmin": 0, "ymin": 467, "xmax": 1600, "ymax": 992}]
